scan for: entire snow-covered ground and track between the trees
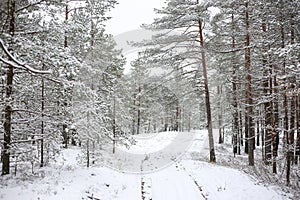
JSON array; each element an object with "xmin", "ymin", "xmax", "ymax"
[{"xmin": 0, "ymin": 131, "xmax": 292, "ymax": 200}]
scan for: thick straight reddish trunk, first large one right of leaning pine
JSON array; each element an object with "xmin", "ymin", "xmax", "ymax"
[{"xmin": 245, "ymin": 1, "xmax": 255, "ymax": 166}]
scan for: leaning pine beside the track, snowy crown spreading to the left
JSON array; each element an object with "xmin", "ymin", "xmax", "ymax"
[{"xmin": 134, "ymin": 0, "xmax": 216, "ymax": 162}]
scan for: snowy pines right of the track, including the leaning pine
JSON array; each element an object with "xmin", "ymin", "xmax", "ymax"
[{"xmin": 136, "ymin": 0, "xmax": 300, "ymax": 184}]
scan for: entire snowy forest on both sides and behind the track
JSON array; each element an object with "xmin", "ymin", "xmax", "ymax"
[{"xmin": 0, "ymin": 0, "xmax": 300, "ymax": 197}]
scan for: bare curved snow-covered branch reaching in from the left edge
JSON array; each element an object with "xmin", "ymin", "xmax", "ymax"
[{"xmin": 0, "ymin": 39, "xmax": 51, "ymax": 74}]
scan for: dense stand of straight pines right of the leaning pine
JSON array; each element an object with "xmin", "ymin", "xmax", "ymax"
[{"xmin": 210, "ymin": 1, "xmax": 300, "ymax": 184}]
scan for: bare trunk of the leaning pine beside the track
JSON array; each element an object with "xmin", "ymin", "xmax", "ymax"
[{"xmin": 198, "ymin": 19, "xmax": 216, "ymax": 162}]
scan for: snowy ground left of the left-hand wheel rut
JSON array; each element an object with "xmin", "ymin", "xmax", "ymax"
[{"xmin": 0, "ymin": 148, "xmax": 140, "ymax": 200}]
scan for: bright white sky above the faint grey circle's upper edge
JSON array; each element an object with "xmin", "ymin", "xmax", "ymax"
[{"xmin": 106, "ymin": 0, "xmax": 165, "ymax": 36}]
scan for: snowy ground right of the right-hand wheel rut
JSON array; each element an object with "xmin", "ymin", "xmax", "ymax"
[{"xmin": 183, "ymin": 161, "xmax": 285, "ymax": 200}]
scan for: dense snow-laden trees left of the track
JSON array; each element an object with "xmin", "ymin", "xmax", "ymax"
[{"xmin": 0, "ymin": 0, "xmax": 126, "ymax": 175}]
